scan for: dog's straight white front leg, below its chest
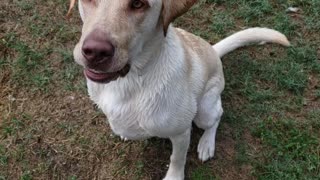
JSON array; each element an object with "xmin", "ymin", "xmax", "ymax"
[{"xmin": 164, "ymin": 129, "xmax": 191, "ymax": 180}]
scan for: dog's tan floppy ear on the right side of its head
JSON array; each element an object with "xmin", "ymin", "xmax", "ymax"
[{"xmin": 162, "ymin": 0, "xmax": 198, "ymax": 35}]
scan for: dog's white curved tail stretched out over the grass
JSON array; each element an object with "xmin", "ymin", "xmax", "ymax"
[{"xmin": 212, "ymin": 28, "xmax": 290, "ymax": 57}]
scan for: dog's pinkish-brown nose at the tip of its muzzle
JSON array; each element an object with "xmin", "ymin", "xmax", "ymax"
[{"xmin": 82, "ymin": 30, "xmax": 115, "ymax": 64}]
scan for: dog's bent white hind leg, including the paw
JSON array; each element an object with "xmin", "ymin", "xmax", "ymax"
[{"xmin": 194, "ymin": 77, "xmax": 223, "ymax": 161}]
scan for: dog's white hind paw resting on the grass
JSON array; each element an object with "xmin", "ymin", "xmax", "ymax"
[{"xmin": 198, "ymin": 130, "xmax": 215, "ymax": 162}]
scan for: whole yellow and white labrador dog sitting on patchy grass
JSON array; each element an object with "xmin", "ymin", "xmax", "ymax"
[{"xmin": 71, "ymin": 0, "xmax": 289, "ymax": 180}]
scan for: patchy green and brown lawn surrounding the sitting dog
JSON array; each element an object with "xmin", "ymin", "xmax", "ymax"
[{"xmin": 0, "ymin": 0, "xmax": 320, "ymax": 180}]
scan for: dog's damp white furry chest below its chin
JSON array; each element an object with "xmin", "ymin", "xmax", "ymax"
[{"xmin": 88, "ymin": 76, "xmax": 197, "ymax": 140}]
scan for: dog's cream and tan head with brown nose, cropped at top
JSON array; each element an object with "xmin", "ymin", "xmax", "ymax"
[{"xmin": 71, "ymin": 0, "xmax": 197, "ymax": 83}]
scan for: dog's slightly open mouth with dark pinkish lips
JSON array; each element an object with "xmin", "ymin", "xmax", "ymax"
[{"xmin": 84, "ymin": 64, "xmax": 130, "ymax": 84}]
